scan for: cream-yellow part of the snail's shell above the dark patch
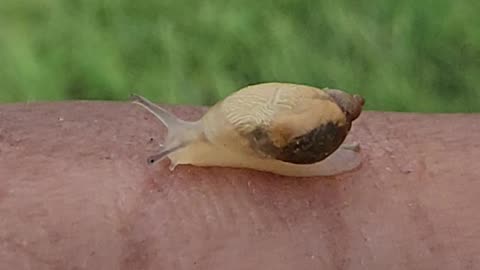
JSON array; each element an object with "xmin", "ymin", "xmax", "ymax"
[{"xmin": 202, "ymin": 83, "xmax": 345, "ymax": 153}]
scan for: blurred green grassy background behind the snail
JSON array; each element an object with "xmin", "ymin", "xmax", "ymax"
[{"xmin": 0, "ymin": 0, "xmax": 480, "ymax": 112}]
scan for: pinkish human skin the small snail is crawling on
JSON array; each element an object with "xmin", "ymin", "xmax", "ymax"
[{"xmin": 0, "ymin": 102, "xmax": 480, "ymax": 270}]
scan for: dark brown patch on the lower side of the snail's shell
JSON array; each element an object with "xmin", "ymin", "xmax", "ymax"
[{"xmin": 248, "ymin": 122, "xmax": 351, "ymax": 164}]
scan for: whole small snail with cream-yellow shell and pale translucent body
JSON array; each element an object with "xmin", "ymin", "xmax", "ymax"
[{"xmin": 131, "ymin": 82, "xmax": 365, "ymax": 177}]
